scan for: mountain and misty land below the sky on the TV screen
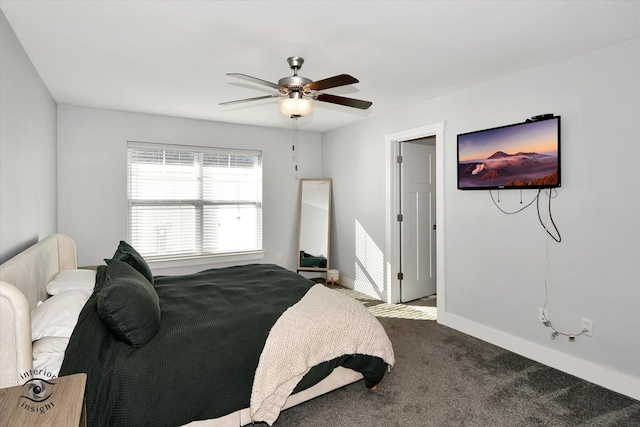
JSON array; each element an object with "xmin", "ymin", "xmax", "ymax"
[{"xmin": 458, "ymin": 151, "xmax": 558, "ymax": 187}]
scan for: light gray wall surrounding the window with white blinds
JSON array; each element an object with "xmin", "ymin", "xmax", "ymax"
[{"xmin": 58, "ymin": 105, "xmax": 322, "ymax": 274}]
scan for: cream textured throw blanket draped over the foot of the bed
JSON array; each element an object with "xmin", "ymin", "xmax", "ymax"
[{"xmin": 250, "ymin": 284, "xmax": 395, "ymax": 425}]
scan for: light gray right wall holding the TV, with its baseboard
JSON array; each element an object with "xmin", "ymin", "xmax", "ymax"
[{"xmin": 322, "ymin": 39, "xmax": 640, "ymax": 399}]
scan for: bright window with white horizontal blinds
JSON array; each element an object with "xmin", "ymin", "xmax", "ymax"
[{"xmin": 127, "ymin": 142, "xmax": 262, "ymax": 260}]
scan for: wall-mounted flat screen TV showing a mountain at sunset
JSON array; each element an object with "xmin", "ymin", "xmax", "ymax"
[{"xmin": 458, "ymin": 116, "xmax": 560, "ymax": 190}]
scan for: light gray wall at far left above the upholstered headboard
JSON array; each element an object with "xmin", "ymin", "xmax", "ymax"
[{"xmin": 0, "ymin": 11, "xmax": 57, "ymax": 263}]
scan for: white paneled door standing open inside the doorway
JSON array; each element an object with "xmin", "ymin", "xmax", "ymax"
[{"xmin": 399, "ymin": 139, "xmax": 436, "ymax": 302}]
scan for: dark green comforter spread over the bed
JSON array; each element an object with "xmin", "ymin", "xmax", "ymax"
[{"xmin": 60, "ymin": 264, "xmax": 386, "ymax": 427}]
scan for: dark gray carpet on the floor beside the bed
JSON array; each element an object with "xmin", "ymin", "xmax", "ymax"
[{"xmin": 255, "ymin": 291, "xmax": 640, "ymax": 427}]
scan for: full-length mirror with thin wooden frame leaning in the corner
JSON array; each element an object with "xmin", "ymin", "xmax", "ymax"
[{"xmin": 298, "ymin": 178, "xmax": 331, "ymax": 271}]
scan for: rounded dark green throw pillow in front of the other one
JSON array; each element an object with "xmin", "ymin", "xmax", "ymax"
[{"xmin": 97, "ymin": 259, "xmax": 160, "ymax": 347}]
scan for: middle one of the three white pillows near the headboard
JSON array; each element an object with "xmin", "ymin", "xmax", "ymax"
[{"xmin": 31, "ymin": 289, "xmax": 93, "ymax": 341}]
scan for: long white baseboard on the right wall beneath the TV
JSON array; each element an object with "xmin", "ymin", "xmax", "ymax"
[{"xmin": 438, "ymin": 313, "xmax": 640, "ymax": 400}]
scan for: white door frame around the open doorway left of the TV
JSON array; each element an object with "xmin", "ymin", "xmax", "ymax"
[{"xmin": 384, "ymin": 122, "xmax": 446, "ymax": 317}]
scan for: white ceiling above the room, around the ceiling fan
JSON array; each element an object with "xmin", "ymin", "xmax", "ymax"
[{"xmin": 0, "ymin": 0, "xmax": 640, "ymax": 132}]
